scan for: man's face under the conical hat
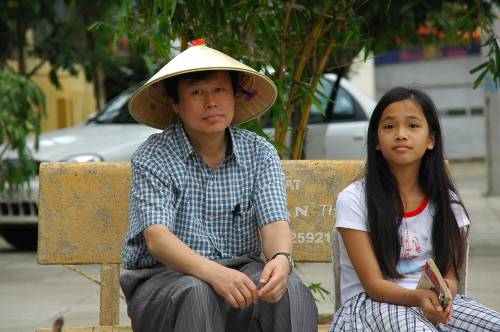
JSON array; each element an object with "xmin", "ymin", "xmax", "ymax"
[{"xmin": 173, "ymin": 71, "xmax": 234, "ymax": 138}]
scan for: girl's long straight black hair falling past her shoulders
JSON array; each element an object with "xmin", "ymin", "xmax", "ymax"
[{"xmin": 365, "ymin": 87, "xmax": 465, "ymax": 278}]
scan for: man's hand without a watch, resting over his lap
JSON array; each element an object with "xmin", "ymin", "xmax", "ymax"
[{"xmin": 207, "ymin": 263, "xmax": 258, "ymax": 309}]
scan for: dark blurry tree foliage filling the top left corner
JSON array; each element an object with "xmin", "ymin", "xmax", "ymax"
[{"xmin": 0, "ymin": 0, "xmax": 116, "ymax": 83}]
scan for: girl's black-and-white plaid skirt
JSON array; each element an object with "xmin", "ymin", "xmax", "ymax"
[{"xmin": 329, "ymin": 293, "xmax": 500, "ymax": 332}]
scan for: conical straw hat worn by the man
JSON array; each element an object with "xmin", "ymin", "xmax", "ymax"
[{"xmin": 129, "ymin": 40, "xmax": 277, "ymax": 129}]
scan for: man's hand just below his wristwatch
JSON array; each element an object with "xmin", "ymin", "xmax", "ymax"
[{"xmin": 257, "ymin": 255, "xmax": 290, "ymax": 303}]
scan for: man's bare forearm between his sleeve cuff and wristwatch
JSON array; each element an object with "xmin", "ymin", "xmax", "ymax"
[{"xmin": 261, "ymin": 221, "xmax": 293, "ymax": 260}]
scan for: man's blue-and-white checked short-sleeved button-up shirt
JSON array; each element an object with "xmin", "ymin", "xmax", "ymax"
[{"xmin": 123, "ymin": 121, "xmax": 289, "ymax": 269}]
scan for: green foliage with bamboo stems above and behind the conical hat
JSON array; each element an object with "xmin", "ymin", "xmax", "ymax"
[{"xmin": 110, "ymin": 0, "xmax": 500, "ymax": 158}]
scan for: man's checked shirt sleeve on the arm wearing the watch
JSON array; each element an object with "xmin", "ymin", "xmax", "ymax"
[{"xmin": 254, "ymin": 151, "xmax": 289, "ymax": 227}]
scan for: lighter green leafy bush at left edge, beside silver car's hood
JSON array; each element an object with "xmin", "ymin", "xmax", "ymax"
[{"xmin": 0, "ymin": 70, "xmax": 45, "ymax": 191}]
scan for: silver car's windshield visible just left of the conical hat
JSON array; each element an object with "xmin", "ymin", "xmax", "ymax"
[{"xmin": 93, "ymin": 86, "xmax": 137, "ymax": 124}]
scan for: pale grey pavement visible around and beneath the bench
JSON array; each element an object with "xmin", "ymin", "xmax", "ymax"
[{"xmin": 0, "ymin": 161, "xmax": 500, "ymax": 332}]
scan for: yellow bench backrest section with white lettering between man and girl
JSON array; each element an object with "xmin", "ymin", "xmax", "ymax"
[{"xmin": 282, "ymin": 160, "xmax": 364, "ymax": 262}]
